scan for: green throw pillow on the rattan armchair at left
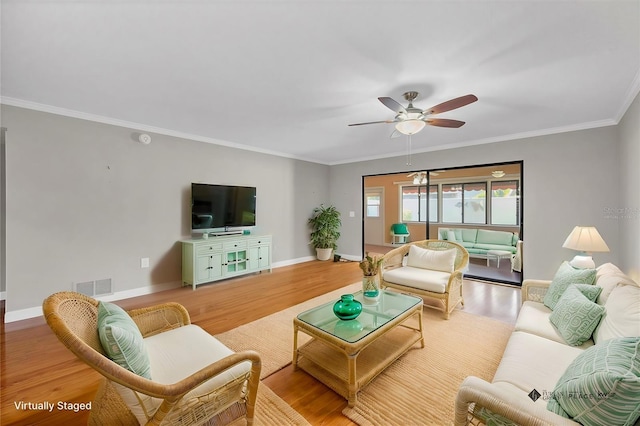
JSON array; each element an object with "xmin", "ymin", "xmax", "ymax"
[{"xmin": 98, "ymin": 302, "xmax": 151, "ymax": 379}]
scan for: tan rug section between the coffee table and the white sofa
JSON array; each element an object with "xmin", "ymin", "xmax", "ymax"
[{"xmin": 342, "ymin": 309, "xmax": 513, "ymax": 426}]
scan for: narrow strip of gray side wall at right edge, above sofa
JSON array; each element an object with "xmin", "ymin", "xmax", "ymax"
[{"xmin": 611, "ymin": 92, "xmax": 640, "ymax": 283}]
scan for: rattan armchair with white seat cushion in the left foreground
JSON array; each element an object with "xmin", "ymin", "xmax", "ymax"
[{"xmin": 43, "ymin": 292, "xmax": 261, "ymax": 425}]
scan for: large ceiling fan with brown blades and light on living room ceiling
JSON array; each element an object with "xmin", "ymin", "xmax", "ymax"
[{"xmin": 349, "ymin": 92, "xmax": 478, "ymax": 138}]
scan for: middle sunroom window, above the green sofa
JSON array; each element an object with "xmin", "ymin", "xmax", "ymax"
[{"xmin": 442, "ymin": 182, "xmax": 487, "ymax": 223}]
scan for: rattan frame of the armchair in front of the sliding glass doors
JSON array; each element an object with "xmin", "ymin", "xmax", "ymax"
[{"xmin": 380, "ymin": 240, "xmax": 469, "ymax": 319}]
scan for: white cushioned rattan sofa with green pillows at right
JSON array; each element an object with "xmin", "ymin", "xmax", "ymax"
[{"xmin": 455, "ymin": 263, "xmax": 640, "ymax": 425}]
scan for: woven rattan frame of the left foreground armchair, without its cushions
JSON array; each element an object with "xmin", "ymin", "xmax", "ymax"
[{"xmin": 43, "ymin": 292, "xmax": 261, "ymax": 425}]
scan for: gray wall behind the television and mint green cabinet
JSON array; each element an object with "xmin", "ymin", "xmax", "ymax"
[{"xmin": 2, "ymin": 105, "xmax": 329, "ymax": 313}]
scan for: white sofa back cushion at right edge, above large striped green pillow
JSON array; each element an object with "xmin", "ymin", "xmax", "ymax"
[{"xmin": 593, "ymin": 285, "xmax": 640, "ymax": 343}]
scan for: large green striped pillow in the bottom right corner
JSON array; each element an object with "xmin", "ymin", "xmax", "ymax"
[{"xmin": 547, "ymin": 337, "xmax": 640, "ymax": 426}]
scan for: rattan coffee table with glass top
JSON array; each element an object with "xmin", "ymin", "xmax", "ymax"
[{"xmin": 293, "ymin": 290, "xmax": 424, "ymax": 407}]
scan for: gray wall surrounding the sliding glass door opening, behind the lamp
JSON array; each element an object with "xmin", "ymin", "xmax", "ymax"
[{"xmin": 331, "ymin": 127, "xmax": 624, "ymax": 279}]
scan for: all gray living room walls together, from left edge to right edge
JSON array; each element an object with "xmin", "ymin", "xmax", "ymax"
[{"xmin": 0, "ymin": 94, "xmax": 640, "ymax": 320}]
